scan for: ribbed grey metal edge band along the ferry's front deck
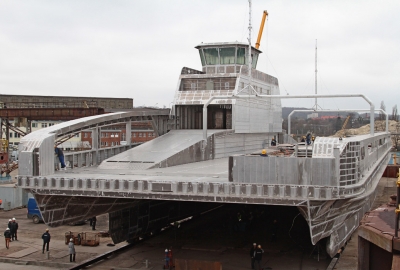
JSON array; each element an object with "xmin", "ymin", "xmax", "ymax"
[{"xmin": 18, "ymin": 172, "xmax": 382, "ymax": 201}]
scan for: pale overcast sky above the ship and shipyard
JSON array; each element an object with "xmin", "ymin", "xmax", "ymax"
[{"xmin": 0, "ymin": 0, "xmax": 400, "ymax": 112}]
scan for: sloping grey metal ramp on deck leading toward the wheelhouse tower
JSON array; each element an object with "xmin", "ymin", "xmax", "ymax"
[{"xmin": 99, "ymin": 130, "xmax": 228, "ymax": 170}]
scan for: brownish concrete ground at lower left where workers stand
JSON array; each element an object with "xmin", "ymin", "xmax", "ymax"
[{"xmin": 0, "ymin": 208, "xmax": 125, "ymax": 269}]
